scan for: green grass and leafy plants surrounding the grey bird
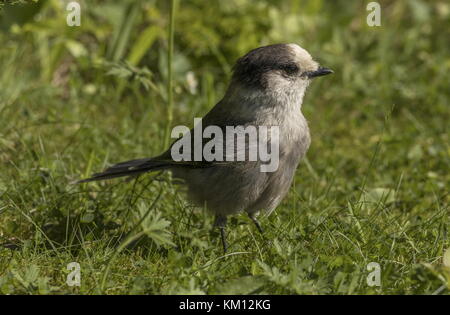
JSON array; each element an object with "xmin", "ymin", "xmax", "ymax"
[{"xmin": 0, "ymin": 0, "xmax": 450, "ymax": 294}]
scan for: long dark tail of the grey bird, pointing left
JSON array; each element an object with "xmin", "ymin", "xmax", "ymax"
[{"xmin": 77, "ymin": 158, "xmax": 171, "ymax": 184}]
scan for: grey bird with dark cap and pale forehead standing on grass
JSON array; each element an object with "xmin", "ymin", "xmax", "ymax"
[{"xmin": 79, "ymin": 43, "xmax": 333, "ymax": 252}]
